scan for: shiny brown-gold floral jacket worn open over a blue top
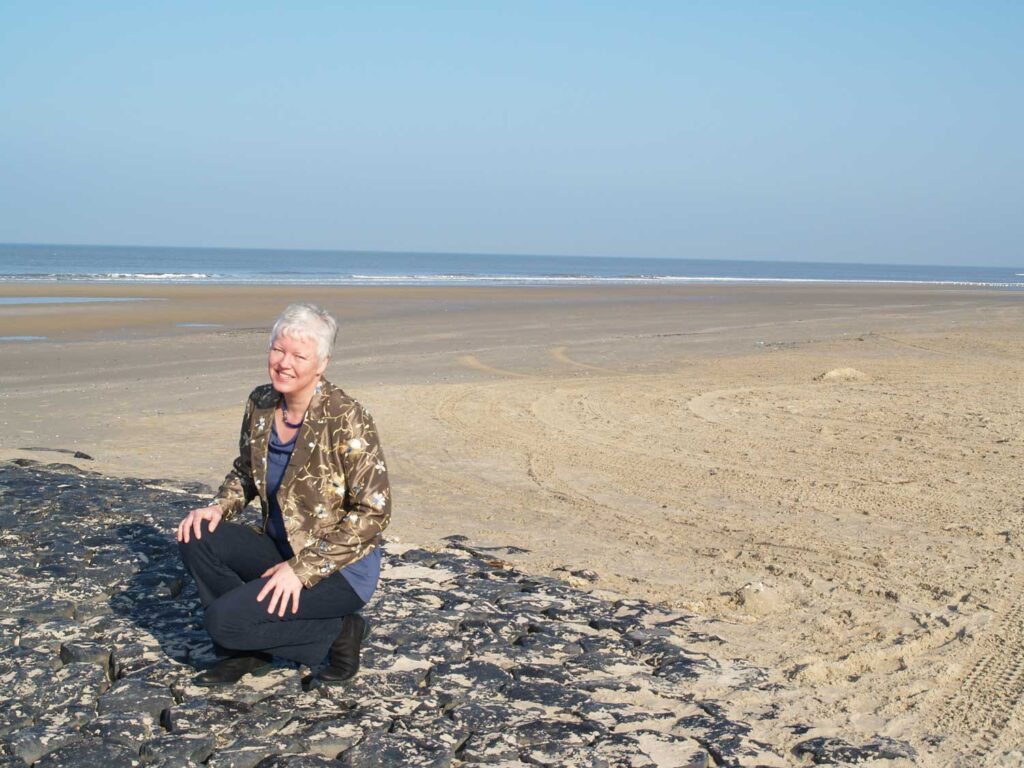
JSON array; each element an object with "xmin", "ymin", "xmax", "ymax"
[{"xmin": 214, "ymin": 380, "xmax": 391, "ymax": 587}]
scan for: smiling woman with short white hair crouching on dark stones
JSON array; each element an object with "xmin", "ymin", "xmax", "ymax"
[{"xmin": 177, "ymin": 304, "xmax": 391, "ymax": 686}]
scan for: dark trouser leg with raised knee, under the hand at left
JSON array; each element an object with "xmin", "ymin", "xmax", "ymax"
[{"xmin": 178, "ymin": 520, "xmax": 281, "ymax": 608}]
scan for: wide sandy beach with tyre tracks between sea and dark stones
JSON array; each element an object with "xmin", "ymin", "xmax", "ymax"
[{"xmin": 0, "ymin": 284, "xmax": 1024, "ymax": 766}]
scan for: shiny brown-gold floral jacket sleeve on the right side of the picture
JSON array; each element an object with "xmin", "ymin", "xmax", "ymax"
[{"xmin": 289, "ymin": 403, "xmax": 391, "ymax": 587}]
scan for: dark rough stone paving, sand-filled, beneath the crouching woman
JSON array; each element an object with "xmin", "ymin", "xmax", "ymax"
[{"xmin": 0, "ymin": 460, "xmax": 912, "ymax": 768}]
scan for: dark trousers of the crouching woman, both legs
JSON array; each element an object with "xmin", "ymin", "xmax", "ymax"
[{"xmin": 178, "ymin": 520, "xmax": 364, "ymax": 668}]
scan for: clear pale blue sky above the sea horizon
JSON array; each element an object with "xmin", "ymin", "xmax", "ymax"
[{"xmin": 0, "ymin": 0, "xmax": 1024, "ymax": 266}]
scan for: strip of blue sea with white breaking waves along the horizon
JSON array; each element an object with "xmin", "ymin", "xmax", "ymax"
[{"xmin": 0, "ymin": 244, "xmax": 1024, "ymax": 290}]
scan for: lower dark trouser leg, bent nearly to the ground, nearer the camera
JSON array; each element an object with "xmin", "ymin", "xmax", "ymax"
[{"xmin": 206, "ymin": 572, "xmax": 364, "ymax": 668}]
